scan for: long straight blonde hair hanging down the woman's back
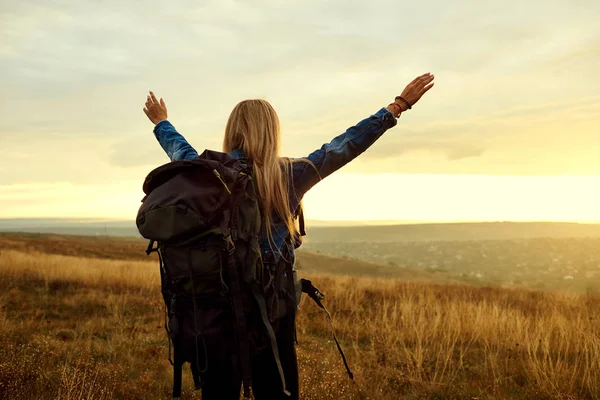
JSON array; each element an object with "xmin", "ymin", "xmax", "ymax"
[{"xmin": 223, "ymin": 99, "xmax": 312, "ymax": 250}]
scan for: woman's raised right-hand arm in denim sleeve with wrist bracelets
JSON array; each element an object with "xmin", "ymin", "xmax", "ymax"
[{"xmin": 294, "ymin": 73, "xmax": 434, "ymax": 195}]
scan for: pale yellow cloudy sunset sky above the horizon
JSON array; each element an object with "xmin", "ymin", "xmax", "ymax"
[{"xmin": 0, "ymin": 0, "xmax": 600, "ymax": 221}]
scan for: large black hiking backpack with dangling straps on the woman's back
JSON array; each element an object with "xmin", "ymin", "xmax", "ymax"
[{"xmin": 136, "ymin": 150, "xmax": 351, "ymax": 397}]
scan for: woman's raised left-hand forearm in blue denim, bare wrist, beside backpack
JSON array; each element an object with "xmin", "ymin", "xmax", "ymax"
[{"xmin": 144, "ymin": 92, "xmax": 198, "ymax": 161}]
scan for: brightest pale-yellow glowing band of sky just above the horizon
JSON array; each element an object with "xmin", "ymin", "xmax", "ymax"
[{"xmin": 0, "ymin": 174, "xmax": 600, "ymax": 222}]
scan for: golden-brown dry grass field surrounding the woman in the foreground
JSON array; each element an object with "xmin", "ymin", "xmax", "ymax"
[{"xmin": 0, "ymin": 235, "xmax": 600, "ymax": 400}]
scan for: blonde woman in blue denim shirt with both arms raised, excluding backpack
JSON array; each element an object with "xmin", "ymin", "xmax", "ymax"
[{"xmin": 144, "ymin": 73, "xmax": 434, "ymax": 400}]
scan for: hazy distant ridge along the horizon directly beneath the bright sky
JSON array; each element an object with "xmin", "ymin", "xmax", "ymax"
[{"xmin": 0, "ymin": 218, "xmax": 600, "ymax": 242}]
